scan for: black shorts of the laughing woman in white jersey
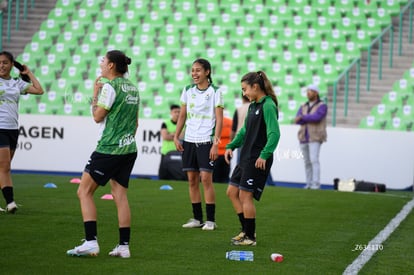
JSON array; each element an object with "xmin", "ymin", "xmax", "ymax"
[{"xmin": 183, "ymin": 141, "xmax": 214, "ymax": 172}]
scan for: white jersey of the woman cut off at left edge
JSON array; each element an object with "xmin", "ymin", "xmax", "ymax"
[{"xmin": 0, "ymin": 77, "xmax": 31, "ymax": 130}]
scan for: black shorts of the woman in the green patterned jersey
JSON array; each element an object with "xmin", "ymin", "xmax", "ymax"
[{"xmin": 84, "ymin": 152, "xmax": 137, "ymax": 188}]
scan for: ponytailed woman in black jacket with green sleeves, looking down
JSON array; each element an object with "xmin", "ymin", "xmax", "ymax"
[{"xmin": 225, "ymin": 71, "xmax": 280, "ymax": 246}]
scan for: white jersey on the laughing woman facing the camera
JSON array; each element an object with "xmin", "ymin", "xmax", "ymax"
[{"xmin": 180, "ymin": 84, "xmax": 224, "ymax": 143}]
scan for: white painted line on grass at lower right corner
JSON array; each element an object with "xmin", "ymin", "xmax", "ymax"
[{"xmin": 343, "ymin": 199, "xmax": 414, "ymax": 275}]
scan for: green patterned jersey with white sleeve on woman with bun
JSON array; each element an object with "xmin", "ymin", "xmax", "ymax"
[{"xmin": 96, "ymin": 77, "xmax": 140, "ymax": 155}]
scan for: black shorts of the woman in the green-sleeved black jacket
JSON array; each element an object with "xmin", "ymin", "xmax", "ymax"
[{"xmin": 229, "ymin": 157, "xmax": 273, "ymax": 201}]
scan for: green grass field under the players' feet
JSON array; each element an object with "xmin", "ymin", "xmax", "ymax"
[{"xmin": 0, "ymin": 174, "xmax": 414, "ymax": 274}]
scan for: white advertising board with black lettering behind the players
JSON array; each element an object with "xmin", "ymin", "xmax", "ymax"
[{"xmin": 12, "ymin": 115, "xmax": 414, "ymax": 189}]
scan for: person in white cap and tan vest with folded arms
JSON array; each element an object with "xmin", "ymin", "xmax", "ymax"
[{"xmin": 295, "ymin": 84, "xmax": 328, "ymax": 189}]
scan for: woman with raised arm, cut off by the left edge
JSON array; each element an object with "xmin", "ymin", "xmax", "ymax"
[{"xmin": 0, "ymin": 51, "xmax": 43, "ymax": 213}]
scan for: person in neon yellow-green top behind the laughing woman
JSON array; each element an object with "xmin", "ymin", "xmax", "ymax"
[{"xmin": 158, "ymin": 104, "xmax": 187, "ymax": 180}]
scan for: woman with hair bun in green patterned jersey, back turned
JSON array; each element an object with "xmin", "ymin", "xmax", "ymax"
[{"xmin": 67, "ymin": 50, "xmax": 139, "ymax": 258}]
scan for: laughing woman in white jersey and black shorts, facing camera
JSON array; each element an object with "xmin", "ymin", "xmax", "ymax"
[{"xmin": 174, "ymin": 58, "xmax": 224, "ymax": 230}]
